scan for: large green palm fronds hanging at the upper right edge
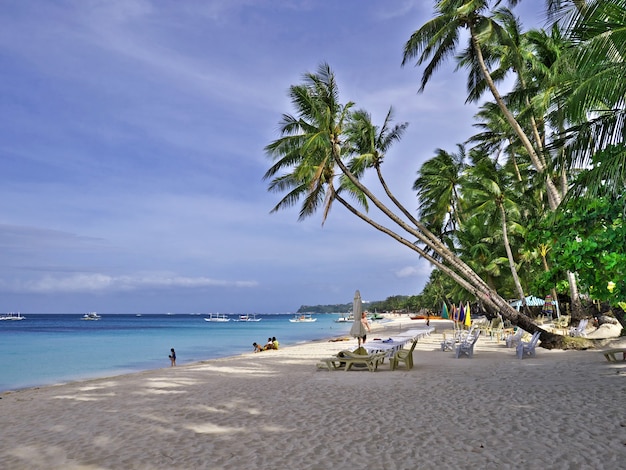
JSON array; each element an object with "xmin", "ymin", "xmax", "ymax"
[{"xmin": 559, "ymin": 0, "xmax": 626, "ymax": 196}]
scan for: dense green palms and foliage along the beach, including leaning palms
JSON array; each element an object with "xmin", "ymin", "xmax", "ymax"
[{"xmin": 265, "ymin": 0, "xmax": 626, "ymax": 344}]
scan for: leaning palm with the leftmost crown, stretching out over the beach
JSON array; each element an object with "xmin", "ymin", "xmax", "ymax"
[{"xmin": 265, "ymin": 64, "xmax": 554, "ymax": 340}]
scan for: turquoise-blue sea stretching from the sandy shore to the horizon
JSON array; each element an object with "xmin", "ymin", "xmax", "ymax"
[{"xmin": 0, "ymin": 314, "xmax": 351, "ymax": 392}]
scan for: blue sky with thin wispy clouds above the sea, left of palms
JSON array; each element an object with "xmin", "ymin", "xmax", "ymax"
[{"xmin": 0, "ymin": 0, "xmax": 540, "ymax": 313}]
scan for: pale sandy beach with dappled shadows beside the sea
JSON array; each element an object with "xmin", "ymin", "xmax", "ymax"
[{"xmin": 0, "ymin": 322, "xmax": 626, "ymax": 469}]
